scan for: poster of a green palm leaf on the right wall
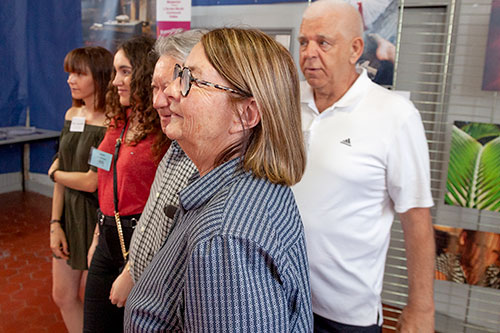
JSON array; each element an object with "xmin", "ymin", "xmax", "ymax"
[{"xmin": 445, "ymin": 121, "xmax": 500, "ymax": 212}]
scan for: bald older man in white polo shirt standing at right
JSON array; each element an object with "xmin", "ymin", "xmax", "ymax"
[{"xmin": 293, "ymin": 0, "xmax": 435, "ymax": 332}]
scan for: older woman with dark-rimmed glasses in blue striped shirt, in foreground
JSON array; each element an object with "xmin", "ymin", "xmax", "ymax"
[{"xmin": 125, "ymin": 28, "xmax": 312, "ymax": 332}]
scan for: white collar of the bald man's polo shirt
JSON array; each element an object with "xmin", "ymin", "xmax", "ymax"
[{"xmin": 301, "ymin": 68, "xmax": 371, "ymax": 113}]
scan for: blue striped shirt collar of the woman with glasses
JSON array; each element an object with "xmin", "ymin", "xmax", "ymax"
[{"xmin": 179, "ymin": 158, "xmax": 244, "ymax": 210}]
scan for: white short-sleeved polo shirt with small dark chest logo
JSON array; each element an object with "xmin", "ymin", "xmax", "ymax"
[{"xmin": 292, "ymin": 70, "xmax": 433, "ymax": 326}]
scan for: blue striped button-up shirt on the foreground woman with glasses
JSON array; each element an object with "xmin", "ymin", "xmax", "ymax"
[{"xmin": 125, "ymin": 159, "xmax": 312, "ymax": 332}]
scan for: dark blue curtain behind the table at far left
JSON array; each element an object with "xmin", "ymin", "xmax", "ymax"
[{"xmin": 0, "ymin": 0, "xmax": 82, "ymax": 173}]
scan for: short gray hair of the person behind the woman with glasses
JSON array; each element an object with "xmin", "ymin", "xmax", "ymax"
[{"xmin": 154, "ymin": 29, "xmax": 207, "ymax": 63}]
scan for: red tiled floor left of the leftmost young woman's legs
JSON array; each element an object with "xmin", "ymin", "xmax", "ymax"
[{"xmin": 0, "ymin": 192, "xmax": 66, "ymax": 333}]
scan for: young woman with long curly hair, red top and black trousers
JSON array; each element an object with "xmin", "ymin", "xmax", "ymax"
[{"xmin": 84, "ymin": 36, "xmax": 169, "ymax": 333}]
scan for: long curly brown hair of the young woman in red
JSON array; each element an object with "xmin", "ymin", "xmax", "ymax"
[{"xmin": 106, "ymin": 36, "xmax": 170, "ymax": 162}]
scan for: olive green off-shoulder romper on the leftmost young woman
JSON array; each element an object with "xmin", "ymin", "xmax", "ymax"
[{"xmin": 58, "ymin": 120, "xmax": 106, "ymax": 270}]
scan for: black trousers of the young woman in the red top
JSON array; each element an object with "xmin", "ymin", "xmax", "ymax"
[{"xmin": 83, "ymin": 224, "xmax": 134, "ymax": 333}]
